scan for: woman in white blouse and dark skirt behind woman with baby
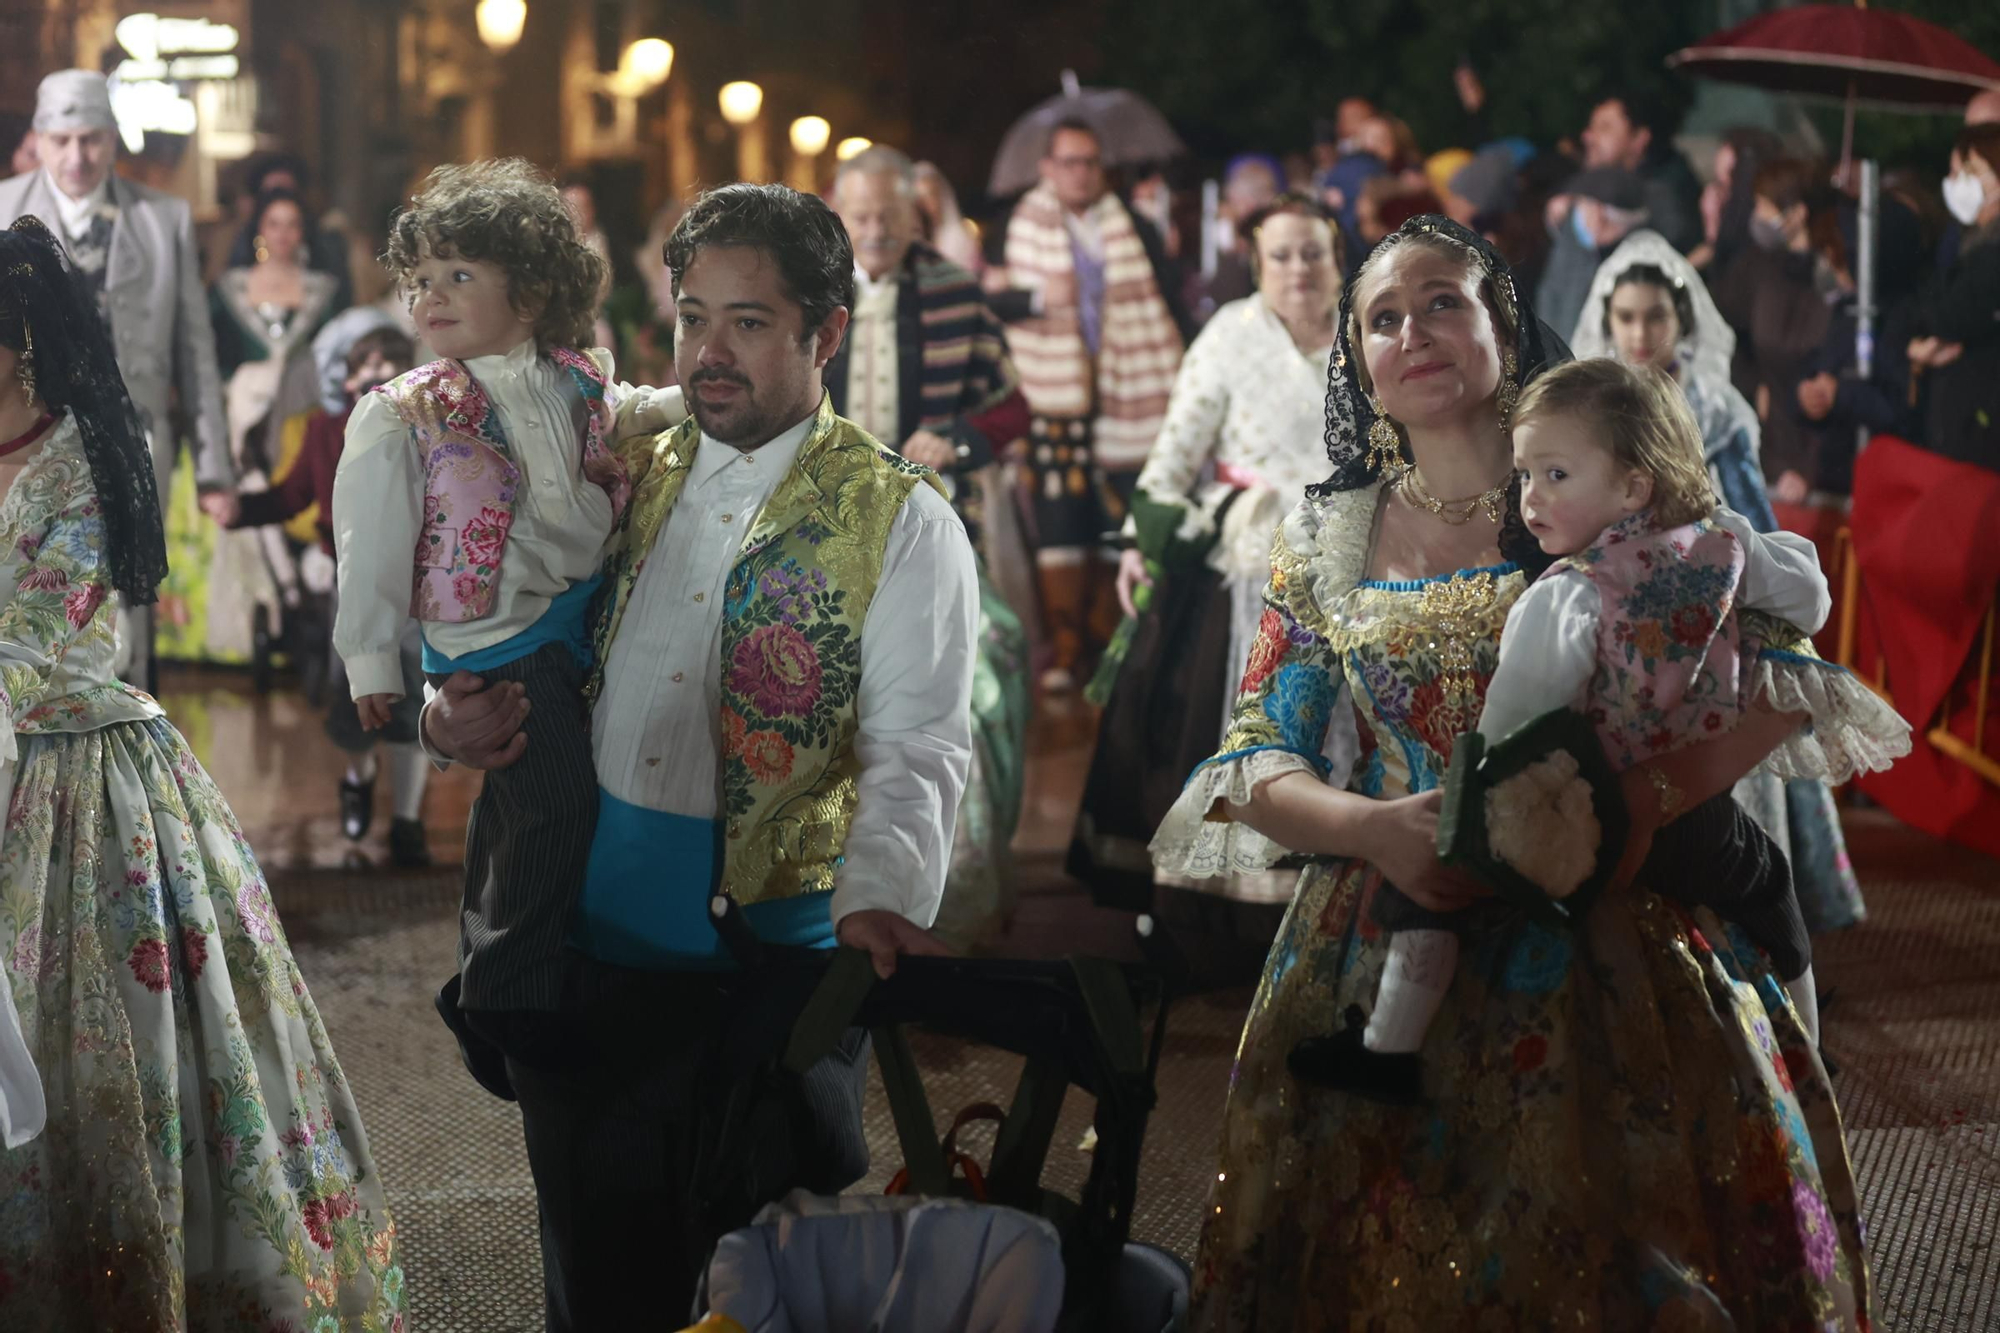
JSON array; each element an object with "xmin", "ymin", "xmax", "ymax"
[{"xmin": 1070, "ymin": 194, "xmax": 1344, "ymax": 904}]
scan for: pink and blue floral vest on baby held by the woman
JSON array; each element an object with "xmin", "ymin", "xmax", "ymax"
[{"xmin": 1556, "ymin": 510, "xmax": 1750, "ymax": 771}]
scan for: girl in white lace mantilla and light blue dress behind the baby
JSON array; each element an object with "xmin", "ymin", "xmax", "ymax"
[{"xmin": 1570, "ymin": 232, "xmax": 1868, "ymax": 931}]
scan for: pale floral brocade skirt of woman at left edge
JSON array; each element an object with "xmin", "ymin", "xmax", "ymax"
[{"xmin": 0, "ymin": 719, "xmax": 404, "ymax": 1333}]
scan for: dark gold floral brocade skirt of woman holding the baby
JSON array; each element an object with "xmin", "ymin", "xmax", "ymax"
[{"xmin": 1192, "ymin": 863, "xmax": 1870, "ymax": 1333}]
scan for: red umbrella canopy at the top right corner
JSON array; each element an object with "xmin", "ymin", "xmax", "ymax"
[{"xmin": 1666, "ymin": 4, "xmax": 2000, "ymax": 112}]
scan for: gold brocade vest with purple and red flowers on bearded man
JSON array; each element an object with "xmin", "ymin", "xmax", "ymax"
[{"xmin": 586, "ymin": 396, "xmax": 942, "ymax": 903}]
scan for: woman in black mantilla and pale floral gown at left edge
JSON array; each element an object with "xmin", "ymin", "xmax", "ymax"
[{"xmin": 0, "ymin": 218, "xmax": 404, "ymax": 1333}]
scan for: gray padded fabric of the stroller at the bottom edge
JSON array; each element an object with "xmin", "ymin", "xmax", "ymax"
[{"xmin": 694, "ymin": 1191, "xmax": 1062, "ymax": 1333}]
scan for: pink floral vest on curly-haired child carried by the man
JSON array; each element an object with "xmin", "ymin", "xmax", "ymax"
[{"xmin": 376, "ymin": 346, "xmax": 632, "ymax": 622}]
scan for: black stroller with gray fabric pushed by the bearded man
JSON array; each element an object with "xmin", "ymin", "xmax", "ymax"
[{"xmin": 694, "ymin": 903, "xmax": 1188, "ymax": 1333}]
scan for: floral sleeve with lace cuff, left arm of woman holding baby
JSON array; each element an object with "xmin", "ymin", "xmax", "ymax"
[{"xmin": 1152, "ymin": 496, "xmax": 1372, "ymax": 877}]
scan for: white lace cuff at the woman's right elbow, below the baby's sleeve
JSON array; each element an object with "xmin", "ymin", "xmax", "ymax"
[{"xmin": 1750, "ymin": 650, "xmax": 1910, "ymax": 785}]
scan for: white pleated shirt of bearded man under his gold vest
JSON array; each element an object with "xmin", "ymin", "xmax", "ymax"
[{"xmin": 590, "ymin": 404, "xmax": 980, "ymax": 927}]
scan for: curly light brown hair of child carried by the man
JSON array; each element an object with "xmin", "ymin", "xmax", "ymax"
[{"xmin": 382, "ymin": 158, "xmax": 610, "ymax": 348}]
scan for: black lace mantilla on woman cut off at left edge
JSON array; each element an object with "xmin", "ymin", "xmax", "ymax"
[{"xmin": 0, "ymin": 214, "xmax": 166, "ymax": 606}]
